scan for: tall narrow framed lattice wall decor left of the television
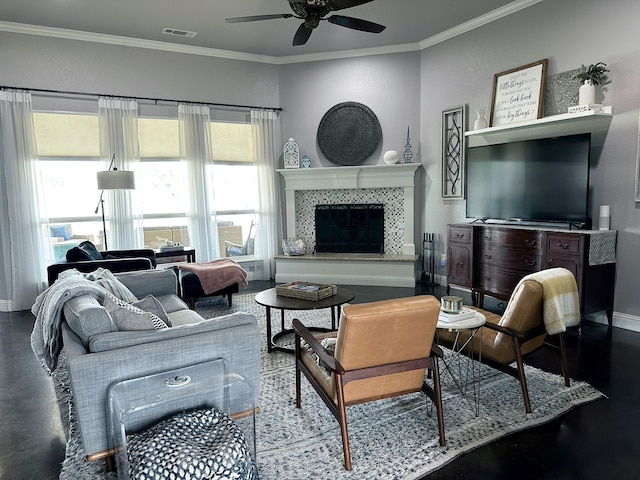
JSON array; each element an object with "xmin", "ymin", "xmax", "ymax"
[{"xmin": 442, "ymin": 105, "xmax": 466, "ymax": 199}]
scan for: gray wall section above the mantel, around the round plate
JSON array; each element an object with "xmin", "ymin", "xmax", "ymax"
[{"xmin": 280, "ymin": 52, "xmax": 420, "ymax": 167}]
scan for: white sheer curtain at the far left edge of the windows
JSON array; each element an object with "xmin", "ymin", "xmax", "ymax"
[{"xmin": 0, "ymin": 91, "xmax": 46, "ymax": 311}]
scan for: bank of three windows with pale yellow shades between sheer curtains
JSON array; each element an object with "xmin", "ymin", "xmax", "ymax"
[{"xmin": 34, "ymin": 106, "xmax": 258, "ymax": 260}]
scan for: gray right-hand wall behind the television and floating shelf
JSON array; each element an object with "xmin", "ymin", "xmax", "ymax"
[{"xmin": 420, "ymin": 0, "xmax": 640, "ymax": 324}]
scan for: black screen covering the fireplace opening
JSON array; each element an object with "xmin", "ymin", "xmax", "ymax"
[{"xmin": 316, "ymin": 203, "xmax": 384, "ymax": 254}]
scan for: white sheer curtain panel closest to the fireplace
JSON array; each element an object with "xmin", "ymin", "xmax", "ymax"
[{"xmin": 251, "ymin": 110, "xmax": 283, "ymax": 280}]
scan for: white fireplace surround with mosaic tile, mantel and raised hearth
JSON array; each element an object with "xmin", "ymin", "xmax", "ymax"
[{"xmin": 276, "ymin": 163, "xmax": 420, "ymax": 287}]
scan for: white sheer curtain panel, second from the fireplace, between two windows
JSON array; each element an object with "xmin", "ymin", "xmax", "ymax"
[{"xmin": 178, "ymin": 104, "xmax": 220, "ymax": 262}]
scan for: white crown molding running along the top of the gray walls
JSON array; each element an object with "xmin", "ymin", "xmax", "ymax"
[{"xmin": 0, "ymin": 0, "xmax": 544, "ymax": 65}]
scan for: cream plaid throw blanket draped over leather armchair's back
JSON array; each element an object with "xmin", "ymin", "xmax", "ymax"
[{"xmin": 514, "ymin": 268, "xmax": 580, "ymax": 335}]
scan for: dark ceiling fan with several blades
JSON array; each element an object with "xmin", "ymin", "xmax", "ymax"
[{"xmin": 226, "ymin": 0, "xmax": 387, "ymax": 46}]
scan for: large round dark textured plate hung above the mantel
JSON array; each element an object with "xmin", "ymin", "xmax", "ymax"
[{"xmin": 318, "ymin": 102, "xmax": 382, "ymax": 166}]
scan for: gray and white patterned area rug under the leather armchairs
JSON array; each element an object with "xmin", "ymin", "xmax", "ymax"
[{"xmin": 54, "ymin": 295, "xmax": 604, "ymax": 480}]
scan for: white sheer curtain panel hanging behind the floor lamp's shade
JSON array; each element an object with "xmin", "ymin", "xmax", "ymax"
[{"xmin": 98, "ymin": 98, "xmax": 144, "ymax": 250}]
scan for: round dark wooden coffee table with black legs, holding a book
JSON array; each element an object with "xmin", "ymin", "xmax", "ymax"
[{"xmin": 255, "ymin": 287, "xmax": 355, "ymax": 353}]
